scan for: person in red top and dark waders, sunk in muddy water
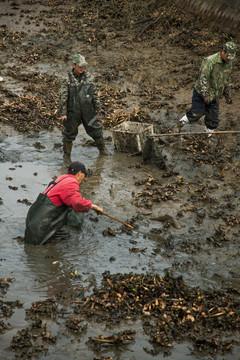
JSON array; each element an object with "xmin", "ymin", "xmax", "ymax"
[{"xmin": 24, "ymin": 161, "xmax": 103, "ymax": 245}]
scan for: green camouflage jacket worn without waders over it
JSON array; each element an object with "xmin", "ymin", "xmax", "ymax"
[{"xmin": 195, "ymin": 52, "xmax": 233, "ymax": 101}]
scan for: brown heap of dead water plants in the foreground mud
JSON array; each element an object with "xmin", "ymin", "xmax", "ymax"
[{"xmin": 1, "ymin": 273, "xmax": 240, "ymax": 359}]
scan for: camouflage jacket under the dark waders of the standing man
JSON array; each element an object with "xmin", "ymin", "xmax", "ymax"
[{"xmin": 59, "ymin": 71, "xmax": 100, "ymax": 116}]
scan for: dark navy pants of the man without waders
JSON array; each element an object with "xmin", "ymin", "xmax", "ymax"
[{"xmin": 186, "ymin": 89, "xmax": 219, "ymax": 130}]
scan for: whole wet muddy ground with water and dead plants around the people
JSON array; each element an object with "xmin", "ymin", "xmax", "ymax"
[{"xmin": 0, "ymin": 0, "xmax": 240, "ymax": 360}]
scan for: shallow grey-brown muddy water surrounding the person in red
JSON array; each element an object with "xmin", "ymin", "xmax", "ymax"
[{"xmin": 0, "ymin": 123, "xmax": 239, "ymax": 360}]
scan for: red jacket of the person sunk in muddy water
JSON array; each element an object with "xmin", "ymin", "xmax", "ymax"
[{"xmin": 43, "ymin": 174, "xmax": 92, "ymax": 211}]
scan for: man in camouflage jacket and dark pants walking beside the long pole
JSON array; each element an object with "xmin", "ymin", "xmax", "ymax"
[{"xmin": 178, "ymin": 41, "xmax": 237, "ymax": 136}]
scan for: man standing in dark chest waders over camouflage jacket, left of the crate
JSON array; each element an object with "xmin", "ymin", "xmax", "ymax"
[{"xmin": 59, "ymin": 55, "xmax": 109, "ymax": 161}]
